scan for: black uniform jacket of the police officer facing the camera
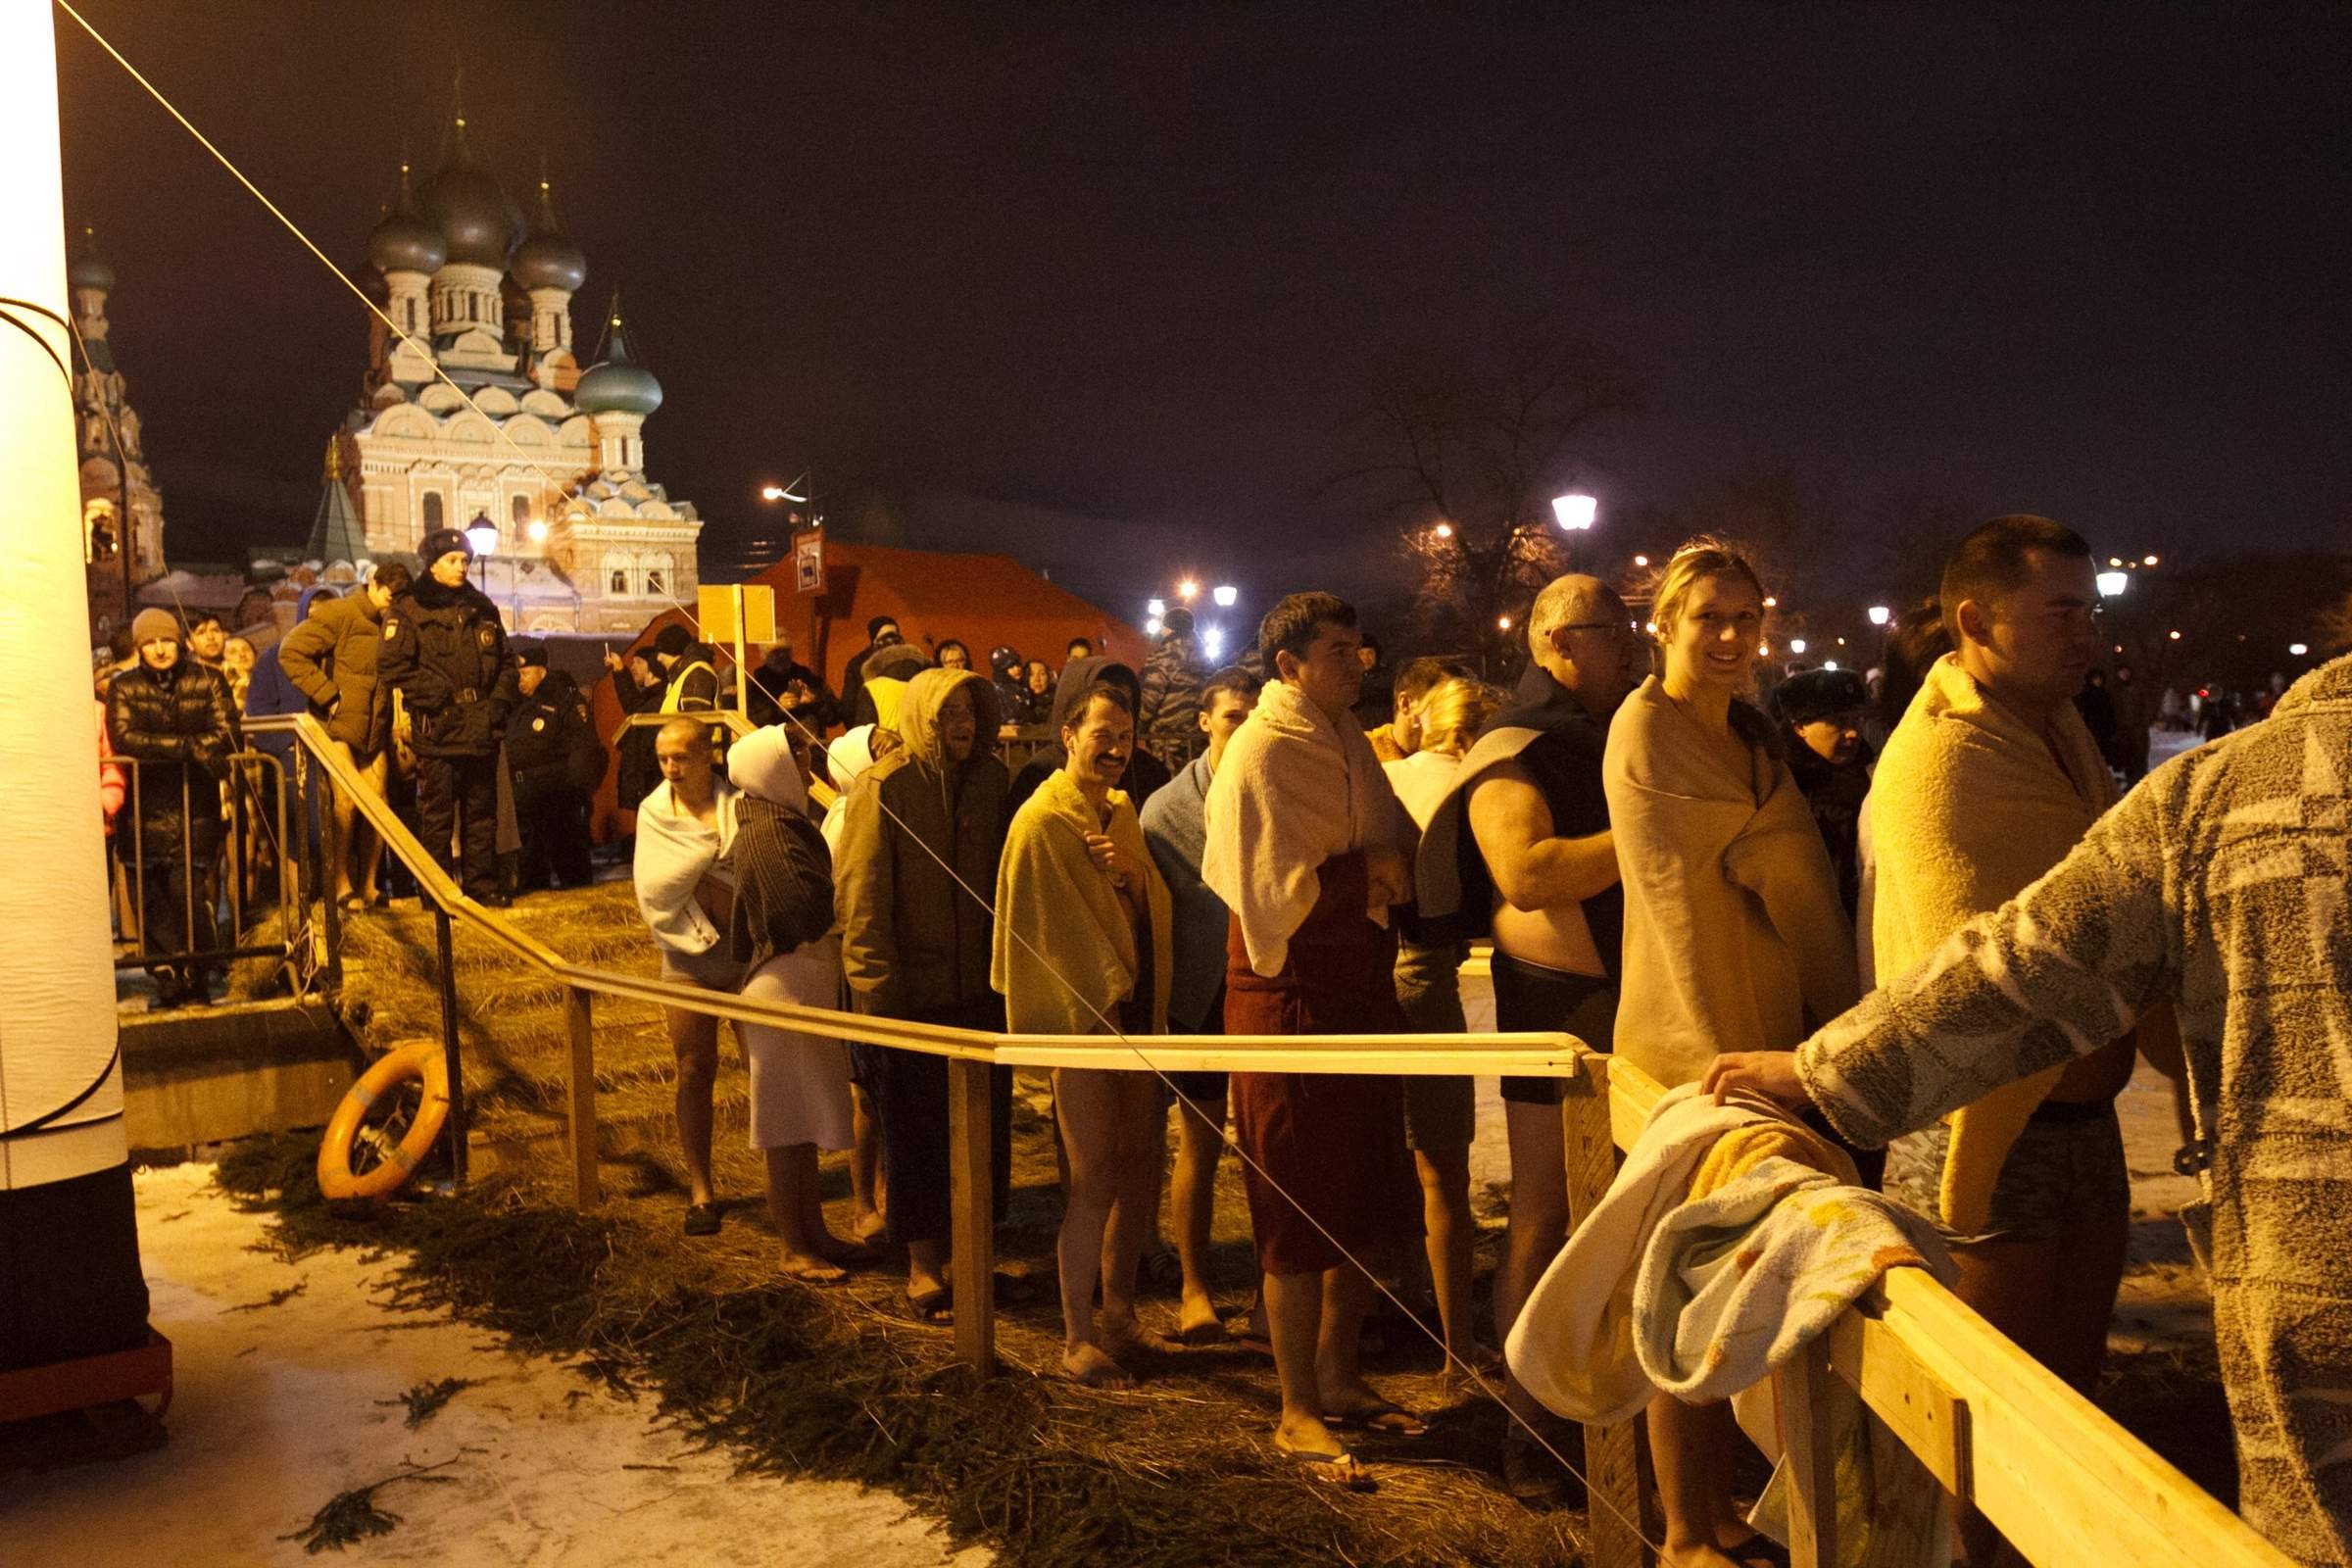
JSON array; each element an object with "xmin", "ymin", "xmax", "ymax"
[{"xmin": 376, "ymin": 576, "xmax": 519, "ymax": 757}]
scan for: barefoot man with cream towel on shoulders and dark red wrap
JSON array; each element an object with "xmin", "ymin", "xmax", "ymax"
[{"xmin": 1201, "ymin": 592, "xmax": 1425, "ymax": 1486}]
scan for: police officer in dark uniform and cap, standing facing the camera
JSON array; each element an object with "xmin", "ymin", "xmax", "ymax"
[{"xmin": 376, "ymin": 529, "xmax": 517, "ymax": 907}]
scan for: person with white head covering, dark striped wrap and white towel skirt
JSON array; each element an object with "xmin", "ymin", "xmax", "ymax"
[{"xmin": 727, "ymin": 724, "xmax": 872, "ymax": 1284}]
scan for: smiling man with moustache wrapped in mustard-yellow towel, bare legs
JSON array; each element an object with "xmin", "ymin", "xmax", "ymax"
[{"xmin": 990, "ymin": 682, "xmax": 1176, "ymax": 1387}]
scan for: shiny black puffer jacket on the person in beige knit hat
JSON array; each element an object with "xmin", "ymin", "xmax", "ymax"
[{"xmin": 106, "ymin": 654, "xmax": 240, "ymax": 860}]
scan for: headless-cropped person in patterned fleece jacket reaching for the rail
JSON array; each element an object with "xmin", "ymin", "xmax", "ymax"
[{"xmin": 1707, "ymin": 659, "xmax": 2352, "ymax": 1568}]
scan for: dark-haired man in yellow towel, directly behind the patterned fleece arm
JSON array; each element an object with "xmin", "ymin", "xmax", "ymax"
[{"xmin": 1872, "ymin": 514, "xmax": 2133, "ymax": 1494}]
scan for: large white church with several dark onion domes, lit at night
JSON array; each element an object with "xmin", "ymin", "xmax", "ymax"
[{"xmin": 331, "ymin": 116, "xmax": 704, "ymax": 632}]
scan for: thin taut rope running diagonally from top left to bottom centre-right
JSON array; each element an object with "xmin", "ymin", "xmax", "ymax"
[{"xmin": 54, "ymin": 0, "xmax": 1665, "ymax": 1554}]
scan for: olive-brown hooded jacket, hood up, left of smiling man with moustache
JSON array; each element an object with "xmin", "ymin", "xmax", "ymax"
[{"xmin": 833, "ymin": 670, "xmax": 1011, "ymax": 1018}]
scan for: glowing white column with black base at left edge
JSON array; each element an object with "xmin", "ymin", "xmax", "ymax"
[{"xmin": 0, "ymin": 0, "xmax": 146, "ymax": 1371}]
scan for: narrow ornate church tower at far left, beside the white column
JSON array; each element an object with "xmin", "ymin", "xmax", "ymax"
[{"xmin": 66, "ymin": 228, "xmax": 165, "ymax": 637}]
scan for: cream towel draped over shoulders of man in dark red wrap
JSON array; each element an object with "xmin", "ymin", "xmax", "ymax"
[{"xmin": 1200, "ymin": 679, "xmax": 1401, "ymax": 973}]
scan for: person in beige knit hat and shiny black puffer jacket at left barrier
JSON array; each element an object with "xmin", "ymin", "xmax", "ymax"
[{"xmin": 106, "ymin": 609, "xmax": 240, "ymax": 1006}]
